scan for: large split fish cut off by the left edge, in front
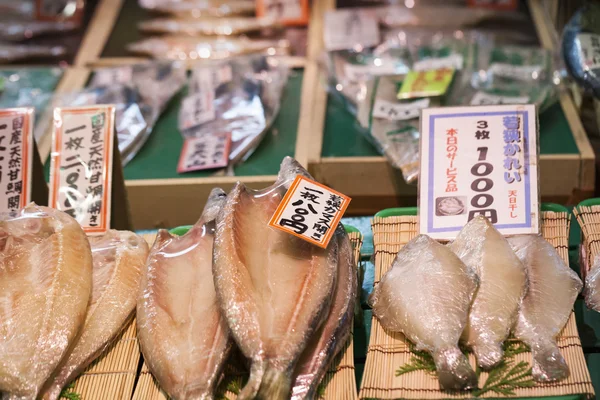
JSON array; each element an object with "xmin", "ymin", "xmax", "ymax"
[{"xmin": 0, "ymin": 204, "xmax": 92, "ymax": 399}]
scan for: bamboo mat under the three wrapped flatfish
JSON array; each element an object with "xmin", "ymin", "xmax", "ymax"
[{"xmin": 360, "ymin": 212, "xmax": 594, "ymax": 399}]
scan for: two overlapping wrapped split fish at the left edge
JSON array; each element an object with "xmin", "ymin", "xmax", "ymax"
[{"xmin": 0, "ymin": 204, "xmax": 148, "ymax": 400}]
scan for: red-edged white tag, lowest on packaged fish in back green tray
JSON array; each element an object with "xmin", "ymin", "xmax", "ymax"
[{"xmin": 177, "ymin": 132, "xmax": 231, "ymax": 174}]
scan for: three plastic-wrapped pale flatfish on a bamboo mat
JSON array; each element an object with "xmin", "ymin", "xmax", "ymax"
[{"xmin": 370, "ymin": 216, "xmax": 582, "ymax": 390}]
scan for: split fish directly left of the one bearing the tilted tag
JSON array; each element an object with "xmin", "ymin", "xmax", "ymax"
[{"xmin": 137, "ymin": 189, "xmax": 232, "ymax": 400}]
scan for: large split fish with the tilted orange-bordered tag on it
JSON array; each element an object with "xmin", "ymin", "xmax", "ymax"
[{"xmin": 213, "ymin": 157, "xmax": 338, "ymax": 400}]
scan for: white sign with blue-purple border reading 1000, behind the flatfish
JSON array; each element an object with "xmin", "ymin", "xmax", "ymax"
[{"xmin": 419, "ymin": 105, "xmax": 540, "ymax": 239}]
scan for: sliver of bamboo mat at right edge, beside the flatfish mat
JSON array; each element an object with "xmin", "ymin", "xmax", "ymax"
[{"xmin": 573, "ymin": 205, "xmax": 600, "ymax": 279}]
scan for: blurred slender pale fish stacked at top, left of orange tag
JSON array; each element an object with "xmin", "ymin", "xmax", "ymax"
[{"xmin": 128, "ymin": 0, "xmax": 290, "ymax": 61}]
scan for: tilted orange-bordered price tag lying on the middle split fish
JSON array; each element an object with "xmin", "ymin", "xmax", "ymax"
[{"xmin": 269, "ymin": 175, "xmax": 351, "ymax": 248}]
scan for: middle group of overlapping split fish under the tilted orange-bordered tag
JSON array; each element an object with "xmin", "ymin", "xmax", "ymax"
[{"xmin": 137, "ymin": 157, "xmax": 357, "ymax": 399}]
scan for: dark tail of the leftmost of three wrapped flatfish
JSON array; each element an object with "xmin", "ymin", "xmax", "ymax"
[{"xmin": 433, "ymin": 346, "xmax": 477, "ymax": 390}]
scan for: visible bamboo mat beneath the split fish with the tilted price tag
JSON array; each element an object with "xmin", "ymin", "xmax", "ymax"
[{"xmin": 131, "ymin": 232, "xmax": 362, "ymax": 400}]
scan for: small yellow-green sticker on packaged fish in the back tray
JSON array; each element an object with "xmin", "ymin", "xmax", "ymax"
[{"xmin": 398, "ymin": 69, "xmax": 454, "ymax": 99}]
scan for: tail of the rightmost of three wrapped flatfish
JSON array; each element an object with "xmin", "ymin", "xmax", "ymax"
[{"xmin": 531, "ymin": 341, "xmax": 569, "ymax": 382}]
